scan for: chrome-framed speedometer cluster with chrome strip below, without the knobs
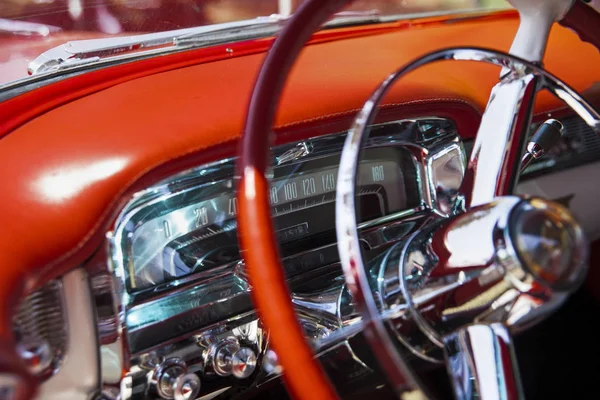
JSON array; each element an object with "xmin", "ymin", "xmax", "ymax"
[{"xmin": 109, "ymin": 117, "xmax": 466, "ymax": 344}]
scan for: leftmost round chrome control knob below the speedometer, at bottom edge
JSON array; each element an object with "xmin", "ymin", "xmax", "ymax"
[{"xmin": 152, "ymin": 358, "xmax": 200, "ymax": 400}]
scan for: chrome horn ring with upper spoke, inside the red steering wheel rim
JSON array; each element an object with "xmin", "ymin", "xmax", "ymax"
[{"xmin": 336, "ymin": 48, "xmax": 600, "ymax": 397}]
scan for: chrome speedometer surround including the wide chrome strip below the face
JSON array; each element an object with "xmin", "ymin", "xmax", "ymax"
[{"xmin": 108, "ymin": 117, "xmax": 466, "ymax": 353}]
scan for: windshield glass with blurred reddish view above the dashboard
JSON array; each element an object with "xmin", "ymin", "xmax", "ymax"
[{"xmin": 0, "ymin": 0, "xmax": 507, "ymax": 85}]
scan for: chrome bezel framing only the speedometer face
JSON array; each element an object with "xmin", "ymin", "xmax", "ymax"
[{"xmin": 111, "ymin": 117, "xmax": 458, "ymax": 300}]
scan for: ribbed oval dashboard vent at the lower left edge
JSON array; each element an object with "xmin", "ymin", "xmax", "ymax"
[{"xmin": 13, "ymin": 280, "xmax": 67, "ymax": 378}]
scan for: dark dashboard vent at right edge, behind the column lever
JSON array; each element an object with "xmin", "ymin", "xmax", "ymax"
[{"xmin": 523, "ymin": 116, "xmax": 600, "ymax": 177}]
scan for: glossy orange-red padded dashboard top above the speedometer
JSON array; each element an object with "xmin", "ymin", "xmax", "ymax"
[{"xmin": 0, "ymin": 7, "xmax": 600, "ymax": 396}]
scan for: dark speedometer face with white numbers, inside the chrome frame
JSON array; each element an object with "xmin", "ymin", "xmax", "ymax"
[{"xmin": 126, "ymin": 148, "xmax": 420, "ymax": 291}]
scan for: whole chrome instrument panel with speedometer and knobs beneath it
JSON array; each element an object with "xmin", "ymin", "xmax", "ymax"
[{"xmin": 104, "ymin": 117, "xmax": 466, "ymax": 399}]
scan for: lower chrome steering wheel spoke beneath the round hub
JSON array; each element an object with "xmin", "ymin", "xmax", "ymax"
[{"xmin": 444, "ymin": 323, "xmax": 525, "ymax": 400}]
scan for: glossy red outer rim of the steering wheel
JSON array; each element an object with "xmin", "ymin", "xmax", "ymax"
[{"xmin": 238, "ymin": 0, "xmax": 593, "ymax": 399}]
